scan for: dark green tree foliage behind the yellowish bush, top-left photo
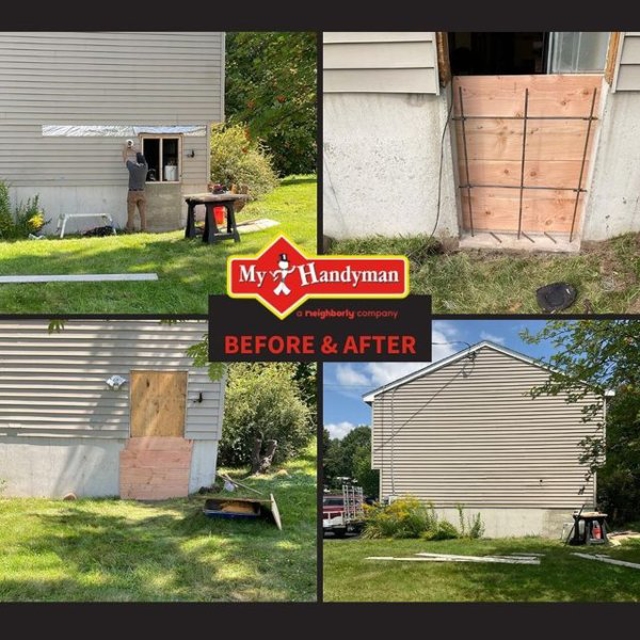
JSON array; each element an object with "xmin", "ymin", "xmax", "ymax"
[{"xmin": 225, "ymin": 32, "xmax": 318, "ymax": 176}]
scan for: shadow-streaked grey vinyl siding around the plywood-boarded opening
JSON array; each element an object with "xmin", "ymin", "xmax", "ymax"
[{"xmin": 0, "ymin": 319, "xmax": 224, "ymax": 440}]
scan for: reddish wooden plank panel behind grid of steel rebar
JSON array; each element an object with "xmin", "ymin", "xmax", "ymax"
[{"xmin": 453, "ymin": 75, "xmax": 602, "ymax": 241}]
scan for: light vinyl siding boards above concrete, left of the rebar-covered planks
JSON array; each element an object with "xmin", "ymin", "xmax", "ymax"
[{"xmin": 323, "ymin": 31, "xmax": 439, "ymax": 94}]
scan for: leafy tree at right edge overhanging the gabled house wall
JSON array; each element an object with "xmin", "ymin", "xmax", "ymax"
[{"xmin": 522, "ymin": 319, "xmax": 640, "ymax": 521}]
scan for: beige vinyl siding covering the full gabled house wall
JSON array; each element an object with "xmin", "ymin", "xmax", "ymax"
[{"xmin": 372, "ymin": 347, "xmax": 595, "ymax": 509}]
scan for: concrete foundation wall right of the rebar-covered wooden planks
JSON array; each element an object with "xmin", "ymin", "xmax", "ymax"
[{"xmin": 582, "ymin": 92, "xmax": 640, "ymax": 241}]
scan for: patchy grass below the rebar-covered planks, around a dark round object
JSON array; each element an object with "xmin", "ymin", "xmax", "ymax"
[{"xmin": 331, "ymin": 234, "xmax": 640, "ymax": 314}]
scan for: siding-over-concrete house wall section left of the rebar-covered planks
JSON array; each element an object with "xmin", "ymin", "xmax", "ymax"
[{"xmin": 323, "ymin": 32, "xmax": 458, "ymax": 239}]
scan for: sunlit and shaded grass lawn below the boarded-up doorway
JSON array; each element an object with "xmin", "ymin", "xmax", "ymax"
[{"xmin": 0, "ymin": 443, "xmax": 317, "ymax": 602}]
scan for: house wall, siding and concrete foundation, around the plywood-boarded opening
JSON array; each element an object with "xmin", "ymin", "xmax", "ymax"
[{"xmin": 0, "ymin": 319, "xmax": 224, "ymax": 496}]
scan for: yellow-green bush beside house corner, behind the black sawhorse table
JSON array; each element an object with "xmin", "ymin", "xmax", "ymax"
[{"xmin": 211, "ymin": 124, "xmax": 278, "ymax": 198}]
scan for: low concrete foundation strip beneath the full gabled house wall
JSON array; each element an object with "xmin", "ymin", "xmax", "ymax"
[{"xmin": 436, "ymin": 505, "xmax": 579, "ymax": 540}]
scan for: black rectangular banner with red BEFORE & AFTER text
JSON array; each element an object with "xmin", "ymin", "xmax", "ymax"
[{"xmin": 209, "ymin": 295, "xmax": 431, "ymax": 362}]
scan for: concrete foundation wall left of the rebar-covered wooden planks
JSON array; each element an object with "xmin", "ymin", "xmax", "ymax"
[{"xmin": 323, "ymin": 93, "xmax": 458, "ymax": 239}]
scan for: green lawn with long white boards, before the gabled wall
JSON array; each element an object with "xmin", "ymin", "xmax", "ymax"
[{"xmin": 323, "ymin": 537, "xmax": 640, "ymax": 602}]
